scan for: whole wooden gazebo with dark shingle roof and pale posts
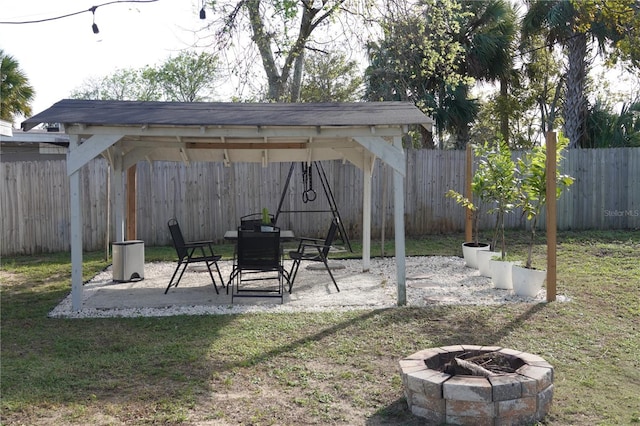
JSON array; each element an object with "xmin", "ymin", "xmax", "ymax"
[{"xmin": 22, "ymin": 99, "xmax": 433, "ymax": 311}]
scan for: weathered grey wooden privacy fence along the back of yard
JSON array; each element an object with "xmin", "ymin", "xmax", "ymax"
[{"xmin": 0, "ymin": 148, "xmax": 640, "ymax": 255}]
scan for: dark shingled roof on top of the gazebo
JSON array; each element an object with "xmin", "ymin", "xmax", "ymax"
[{"xmin": 22, "ymin": 99, "xmax": 431, "ymax": 130}]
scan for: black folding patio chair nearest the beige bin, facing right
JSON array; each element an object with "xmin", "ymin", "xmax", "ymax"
[{"xmin": 164, "ymin": 219, "xmax": 224, "ymax": 294}]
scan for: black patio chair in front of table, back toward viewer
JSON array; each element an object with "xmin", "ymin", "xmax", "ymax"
[{"xmin": 227, "ymin": 227, "xmax": 288, "ymax": 303}]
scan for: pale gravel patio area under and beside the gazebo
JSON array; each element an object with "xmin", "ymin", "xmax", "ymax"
[{"xmin": 49, "ymin": 256, "xmax": 546, "ymax": 318}]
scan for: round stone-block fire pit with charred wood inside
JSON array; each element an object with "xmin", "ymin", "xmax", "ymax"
[{"xmin": 400, "ymin": 345, "xmax": 553, "ymax": 426}]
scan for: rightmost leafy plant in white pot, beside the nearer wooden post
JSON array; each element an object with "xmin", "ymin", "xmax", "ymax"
[{"xmin": 512, "ymin": 134, "xmax": 573, "ymax": 297}]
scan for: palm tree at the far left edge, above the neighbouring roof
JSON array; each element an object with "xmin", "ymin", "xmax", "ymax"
[{"xmin": 0, "ymin": 49, "xmax": 35, "ymax": 122}]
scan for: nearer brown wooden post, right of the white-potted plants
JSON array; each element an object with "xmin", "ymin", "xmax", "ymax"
[{"xmin": 546, "ymin": 132, "xmax": 558, "ymax": 302}]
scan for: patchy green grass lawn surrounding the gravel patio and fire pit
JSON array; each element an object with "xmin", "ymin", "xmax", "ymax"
[{"xmin": 0, "ymin": 231, "xmax": 640, "ymax": 425}]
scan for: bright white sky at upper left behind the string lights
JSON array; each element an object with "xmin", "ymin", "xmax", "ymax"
[{"xmin": 0, "ymin": 0, "xmax": 205, "ymax": 125}]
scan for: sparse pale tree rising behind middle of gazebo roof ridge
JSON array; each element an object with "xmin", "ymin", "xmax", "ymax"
[{"xmin": 300, "ymin": 52, "xmax": 363, "ymax": 102}]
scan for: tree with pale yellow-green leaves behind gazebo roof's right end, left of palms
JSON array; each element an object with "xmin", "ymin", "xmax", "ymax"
[{"xmin": 365, "ymin": 0, "xmax": 471, "ymax": 147}]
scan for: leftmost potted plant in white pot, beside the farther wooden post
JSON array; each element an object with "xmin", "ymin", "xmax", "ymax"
[{"xmin": 445, "ymin": 146, "xmax": 490, "ymax": 268}]
